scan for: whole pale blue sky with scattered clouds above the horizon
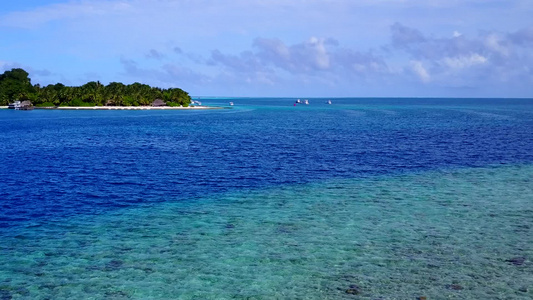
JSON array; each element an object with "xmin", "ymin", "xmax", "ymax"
[{"xmin": 0, "ymin": 0, "xmax": 533, "ymax": 98}]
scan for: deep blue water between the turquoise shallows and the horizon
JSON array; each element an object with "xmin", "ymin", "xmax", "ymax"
[{"xmin": 0, "ymin": 99, "xmax": 533, "ymax": 229}]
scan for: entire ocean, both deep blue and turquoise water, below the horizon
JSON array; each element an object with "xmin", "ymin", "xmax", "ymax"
[{"xmin": 0, "ymin": 98, "xmax": 533, "ymax": 299}]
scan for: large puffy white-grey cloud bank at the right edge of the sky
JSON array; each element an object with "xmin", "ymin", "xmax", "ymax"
[{"xmin": 391, "ymin": 23, "xmax": 533, "ymax": 93}]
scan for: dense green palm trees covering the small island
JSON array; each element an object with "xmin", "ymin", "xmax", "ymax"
[{"xmin": 0, "ymin": 69, "xmax": 191, "ymax": 106}]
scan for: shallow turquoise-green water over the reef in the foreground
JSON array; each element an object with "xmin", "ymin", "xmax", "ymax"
[{"xmin": 0, "ymin": 166, "xmax": 533, "ymax": 299}]
